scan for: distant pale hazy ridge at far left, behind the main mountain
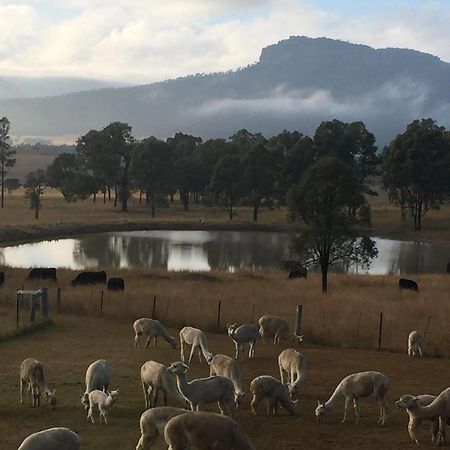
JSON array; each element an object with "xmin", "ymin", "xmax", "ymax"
[{"xmin": 0, "ymin": 76, "xmax": 119, "ymax": 99}]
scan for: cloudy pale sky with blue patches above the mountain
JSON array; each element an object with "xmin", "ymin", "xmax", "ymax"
[{"xmin": 0, "ymin": 0, "xmax": 450, "ymax": 83}]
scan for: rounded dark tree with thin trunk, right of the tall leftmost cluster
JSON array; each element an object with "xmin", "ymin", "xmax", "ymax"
[{"xmin": 130, "ymin": 137, "xmax": 172, "ymax": 217}]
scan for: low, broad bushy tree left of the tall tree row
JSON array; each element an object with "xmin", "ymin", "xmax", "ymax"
[{"xmin": 47, "ymin": 153, "xmax": 98, "ymax": 202}]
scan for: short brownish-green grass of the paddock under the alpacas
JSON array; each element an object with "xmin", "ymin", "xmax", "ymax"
[{"xmin": 0, "ymin": 315, "xmax": 450, "ymax": 450}]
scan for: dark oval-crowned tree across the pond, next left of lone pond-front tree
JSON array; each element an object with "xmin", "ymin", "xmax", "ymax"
[{"xmin": 242, "ymin": 145, "xmax": 276, "ymax": 222}]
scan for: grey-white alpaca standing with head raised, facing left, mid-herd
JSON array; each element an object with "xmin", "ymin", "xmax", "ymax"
[{"xmin": 167, "ymin": 361, "xmax": 235, "ymax": 416}]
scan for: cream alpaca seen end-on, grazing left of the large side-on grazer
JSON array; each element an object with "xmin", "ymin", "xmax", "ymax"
[{"xmin": 278, "ymin": 348, "xmax": 308, "ymax": 399}]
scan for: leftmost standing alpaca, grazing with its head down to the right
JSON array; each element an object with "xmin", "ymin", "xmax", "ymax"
[{"xmin": 20, "ymin": 358, "xmax": 56, "ymax": 409}]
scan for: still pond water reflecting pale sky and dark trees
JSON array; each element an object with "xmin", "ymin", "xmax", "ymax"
[{"xmin": 0, "ymin": 231, "xmax": 450, "ymax": 274}]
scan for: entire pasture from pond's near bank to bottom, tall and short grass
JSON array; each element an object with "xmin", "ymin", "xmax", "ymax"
[{"xmin": 0, "ymin": 269, "xmax": 450, "ymax": 450}]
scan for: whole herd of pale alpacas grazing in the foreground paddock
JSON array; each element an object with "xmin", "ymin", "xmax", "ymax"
[{"xmin": 18, "ymin": 315, "xmax": 434, "ymax": 450}]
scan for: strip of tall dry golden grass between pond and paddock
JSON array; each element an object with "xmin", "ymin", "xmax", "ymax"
[{"xmin": 1, "ymin": 269, "xmax": 450, "ymax": 357}]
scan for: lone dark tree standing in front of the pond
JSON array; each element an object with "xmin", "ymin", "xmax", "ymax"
[{"xmin": 289, "ymin": 156, "xmax": 377, "ymax": 292}]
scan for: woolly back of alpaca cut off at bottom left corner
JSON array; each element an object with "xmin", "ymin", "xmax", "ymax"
[{"xmin": 18, "ymin": 428, "xmax": 80, "ymax": 450}]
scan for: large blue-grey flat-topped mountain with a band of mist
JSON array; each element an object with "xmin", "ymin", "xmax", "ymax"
[{"xmin": 0, "ymin": 37, "xmax": 450, "ymax": 145}]
